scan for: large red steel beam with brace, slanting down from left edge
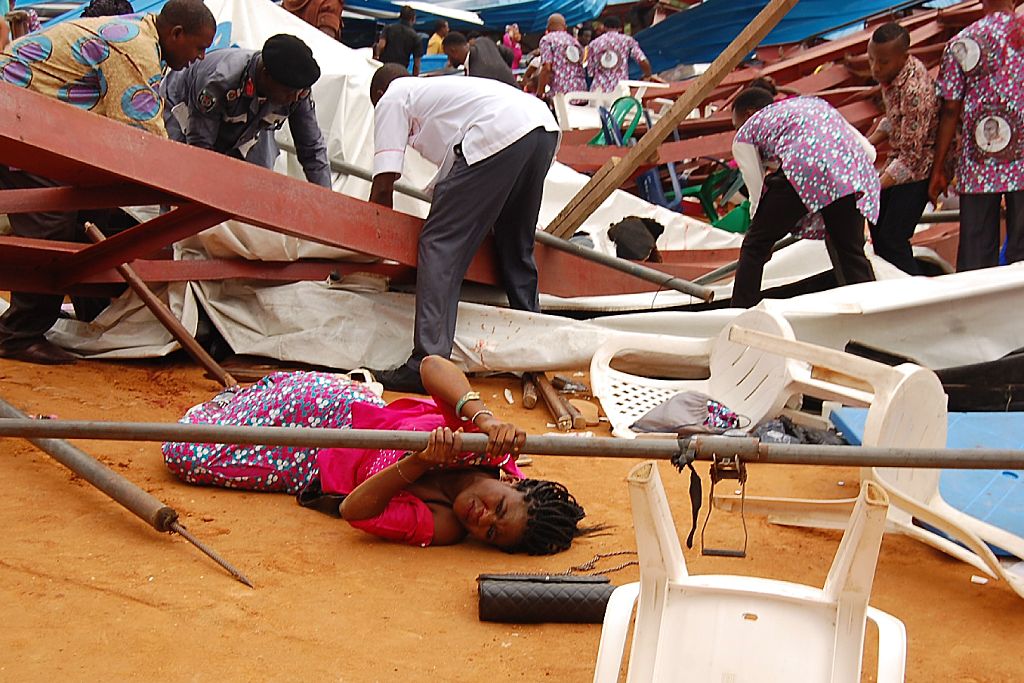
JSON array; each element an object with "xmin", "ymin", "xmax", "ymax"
[{"xmin": 0, "ymin": 84, "xmax": 720, "ymax": 296}]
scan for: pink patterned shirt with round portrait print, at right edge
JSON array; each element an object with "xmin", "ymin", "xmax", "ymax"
[{"xmin": 936, "ymin": 12, "xmax": 1024, "ymax": 195}]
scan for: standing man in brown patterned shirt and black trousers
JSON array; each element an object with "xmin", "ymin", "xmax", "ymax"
[{"xmin": 867, "ymin": 23, "xmax": 939, "ymax": 275}]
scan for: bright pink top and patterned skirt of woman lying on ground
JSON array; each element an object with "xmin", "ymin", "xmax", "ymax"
[{"xmin": 163, "ymin": 372, "xmax": 523, "ymax": 546}]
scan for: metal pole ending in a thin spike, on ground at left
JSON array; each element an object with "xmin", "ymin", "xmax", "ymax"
[{"xmin": 0, "ymin": 398, "xmax": 253, "ymax": 588}]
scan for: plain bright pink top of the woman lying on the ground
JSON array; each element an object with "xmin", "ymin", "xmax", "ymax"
[{"xmin": 316, "ymin": 398, "xmax": 522, "ymax": 546}]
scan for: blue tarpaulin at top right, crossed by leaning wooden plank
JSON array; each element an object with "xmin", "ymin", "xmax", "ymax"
[{"xmin": 636, "ymin": 0, "xmax": 937, "ymax": 72}]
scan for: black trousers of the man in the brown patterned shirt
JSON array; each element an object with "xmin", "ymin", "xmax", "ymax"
[{"xmin": 868, "ymin": 180, "xmax": 928, "ymax": 275}]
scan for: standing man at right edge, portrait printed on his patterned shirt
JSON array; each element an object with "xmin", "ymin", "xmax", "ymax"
[{"xmin": 929, "ymin": 0, "xmax": 1024, "ymax": 270}]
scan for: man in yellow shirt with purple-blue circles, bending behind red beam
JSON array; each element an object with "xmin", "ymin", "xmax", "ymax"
[{"xmin": 0, "ymin": 0, "xmax": 217, "ymax": 365}]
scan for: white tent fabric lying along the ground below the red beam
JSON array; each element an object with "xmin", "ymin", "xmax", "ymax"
[{"xmin": 37, "ymin": 263, "xmax": 1024, "ymax": 371}]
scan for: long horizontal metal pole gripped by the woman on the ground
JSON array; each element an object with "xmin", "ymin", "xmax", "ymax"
[{"xmin": 0, "ymin": 419, "xmax": 1024, "ymax": 469}]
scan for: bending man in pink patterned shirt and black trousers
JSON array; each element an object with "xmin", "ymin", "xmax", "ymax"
[{"xmin": 732, "ymin": 88, "xmax": 879, "ymax": 308}]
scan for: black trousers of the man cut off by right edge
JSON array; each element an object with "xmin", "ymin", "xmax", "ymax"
[{"xmin": 956, "ymin": 190, "xmax": 1024, "ymax": 271}]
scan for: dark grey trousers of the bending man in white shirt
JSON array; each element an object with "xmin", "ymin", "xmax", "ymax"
[{"xmin": 406, "ymin": 128, "xmax": 558, "ymax": 370}]
